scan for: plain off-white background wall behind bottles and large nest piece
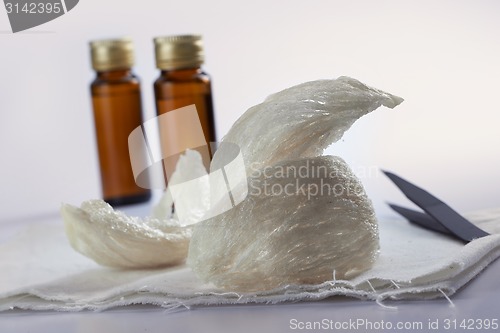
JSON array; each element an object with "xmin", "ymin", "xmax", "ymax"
[{"xmin": 0, "ymin": 0, "xmax": 500, "ymax": 223}]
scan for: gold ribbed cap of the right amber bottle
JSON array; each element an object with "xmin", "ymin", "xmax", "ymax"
[{"xmin": 154, "ymin": 35, "xmax": 205, "ymax": 70}]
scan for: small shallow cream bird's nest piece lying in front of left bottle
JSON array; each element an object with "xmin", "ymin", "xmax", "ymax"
[{"xmin": 61, "ymin": 200, "xmax": 192, "ymax": 268}]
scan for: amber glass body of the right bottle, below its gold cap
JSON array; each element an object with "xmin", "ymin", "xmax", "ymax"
[{"xmin": 154, "ymin": 68, "xmax": 216, "ymax": 177}]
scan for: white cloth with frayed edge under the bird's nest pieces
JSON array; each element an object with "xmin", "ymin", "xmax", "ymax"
[{"xmin": 0, "ymin": 209, "xmax": 500, "ymax": 311}]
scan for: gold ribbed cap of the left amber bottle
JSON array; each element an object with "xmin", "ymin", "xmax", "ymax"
[{"xmin": 90, "ymin": 38, "xmax": 134, "ymax": 71}]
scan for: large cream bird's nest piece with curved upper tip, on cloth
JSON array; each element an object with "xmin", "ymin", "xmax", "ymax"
[{"xmin": 187, "ymin": 77, "xmax": 403, "ymax": 291}]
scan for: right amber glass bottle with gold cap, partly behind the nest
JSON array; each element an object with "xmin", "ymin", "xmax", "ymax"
[{"xmin": 154, "ymin": 35, "xmax": 216, "ymax": 177}]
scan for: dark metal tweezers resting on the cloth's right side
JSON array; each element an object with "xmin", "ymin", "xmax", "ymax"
[{"xmin": 383, "ymin": 171, "xmax": 489, "ymax": 243}]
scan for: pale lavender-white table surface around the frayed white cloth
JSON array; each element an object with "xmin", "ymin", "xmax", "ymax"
[{"xmin": 0, "ymin": 201, "xmax": 500, "ymax": 333}]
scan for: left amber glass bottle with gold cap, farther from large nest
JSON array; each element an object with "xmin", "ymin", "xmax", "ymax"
[{"xmin": 90, "ymin": 39, "xmax": 151, "ymax": 206}]
